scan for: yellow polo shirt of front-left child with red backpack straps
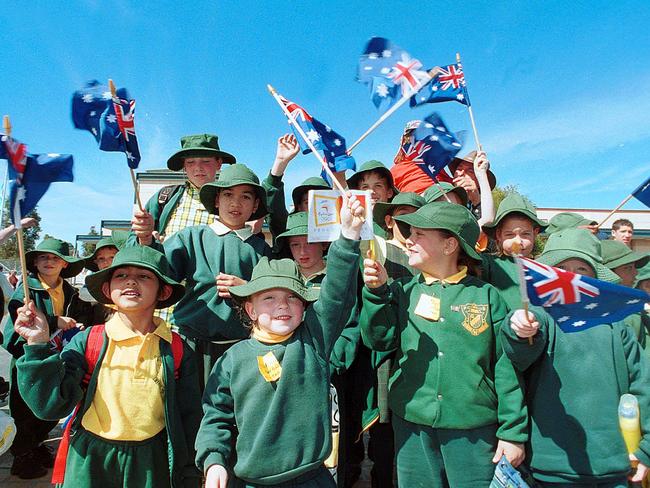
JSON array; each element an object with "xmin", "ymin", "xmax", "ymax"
[{"xmin": 81, "ymin": 314, "xmax": 172, "ymax": 441}]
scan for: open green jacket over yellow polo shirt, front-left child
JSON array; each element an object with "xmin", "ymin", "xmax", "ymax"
[{"xmin": 16, "ymin": 330, "xmax": 201, "ymax": 487}]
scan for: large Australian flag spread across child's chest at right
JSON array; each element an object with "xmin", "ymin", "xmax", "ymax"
[{"xmin": 518, "ymin": 258, "xmax": 650, "ymax": 332}]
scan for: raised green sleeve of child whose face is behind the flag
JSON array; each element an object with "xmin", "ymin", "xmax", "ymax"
[{"xmin": 499, "ymin": 306, "xmax": 555, "ymax": 372}]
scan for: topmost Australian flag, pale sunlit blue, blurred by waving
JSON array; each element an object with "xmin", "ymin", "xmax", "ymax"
[{"xmin": 357, "ymin": 37, "xmax": 430, "ymax": 112}]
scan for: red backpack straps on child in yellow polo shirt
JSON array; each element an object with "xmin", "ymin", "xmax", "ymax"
[{"xmin": 52, "ymin": 324, "xmax": 183, "ymax": 484}]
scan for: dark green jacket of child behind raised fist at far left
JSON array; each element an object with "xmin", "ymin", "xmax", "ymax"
[{"xmin": 2, "ymin": 274, "xmax": 95, "ymax": 358}]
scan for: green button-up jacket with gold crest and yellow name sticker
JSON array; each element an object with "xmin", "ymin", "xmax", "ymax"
[{"xmin": 361, "ymin": 274, "xmax": 527, "ymax": 442}]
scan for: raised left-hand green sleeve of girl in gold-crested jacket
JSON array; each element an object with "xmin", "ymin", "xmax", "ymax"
[{"xmin": 359, "ymin": 281, "xmax": 400, "ymax": 351}]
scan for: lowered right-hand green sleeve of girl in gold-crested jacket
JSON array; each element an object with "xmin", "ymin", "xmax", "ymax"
[{"xmin": 490, "ymin": 288, "xmax": 528, "ymax": 442}]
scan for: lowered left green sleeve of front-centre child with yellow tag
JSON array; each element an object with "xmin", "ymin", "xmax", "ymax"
[{"xmin": 195, "ymin": 353, "xmax": 235, "ymax": 473}]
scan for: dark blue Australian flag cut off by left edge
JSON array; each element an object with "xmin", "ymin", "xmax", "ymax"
[{"xmin": 0, "ymin": 136, "xmax": 73, "ymax": 228}]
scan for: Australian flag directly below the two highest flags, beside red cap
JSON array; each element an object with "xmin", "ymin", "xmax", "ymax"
[{"xmin": 401, "ymin": 112, "xmax": 463, "ymax": 180}]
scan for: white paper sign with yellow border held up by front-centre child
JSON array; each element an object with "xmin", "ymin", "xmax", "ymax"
[{"xmin": 307, "ymin": 190, "xmax": 374, "ymax": 242}]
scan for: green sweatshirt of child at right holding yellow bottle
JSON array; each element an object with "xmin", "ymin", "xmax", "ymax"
[{"xmin": 501, "ymin": 307, "xmax": 650, "ymax": 483}]
